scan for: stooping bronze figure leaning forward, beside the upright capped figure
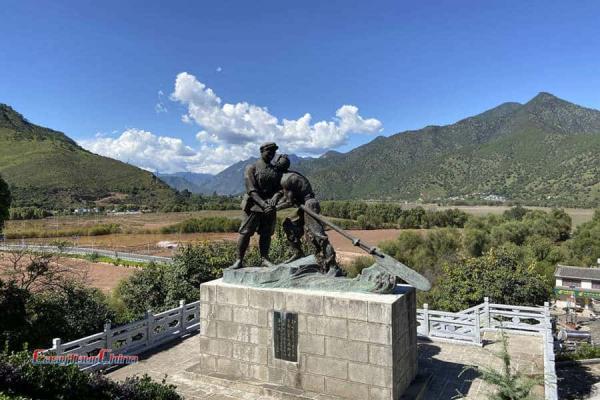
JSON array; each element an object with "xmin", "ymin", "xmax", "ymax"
[{"xmin": 275, "ymin": 154, "xmax": 343, "ymax": 276}]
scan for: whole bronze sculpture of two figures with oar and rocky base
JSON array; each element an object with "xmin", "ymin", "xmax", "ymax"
[{"xmin": 223, "ymin": 143, "xmax": 428, "ymax": 293}]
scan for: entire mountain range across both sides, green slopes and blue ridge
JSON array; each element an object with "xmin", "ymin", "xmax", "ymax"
[{"xmin": 0, "ymin": 92, "xmax": 600, "ymax": 207}]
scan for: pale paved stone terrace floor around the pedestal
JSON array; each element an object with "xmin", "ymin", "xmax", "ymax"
[{"xmin": 108, "ymin": 332, "xmax": 544, "ymax": 400}]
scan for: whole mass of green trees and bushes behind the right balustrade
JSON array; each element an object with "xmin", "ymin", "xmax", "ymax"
[{"xmin": 381, "ymin": 207, "xmax": 580, "ymax": 311}]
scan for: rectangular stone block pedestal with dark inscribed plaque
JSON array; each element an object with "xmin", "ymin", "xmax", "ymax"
[{"xmin": 200, "ymin": 279, "xmax": 417, "ymax": 400}]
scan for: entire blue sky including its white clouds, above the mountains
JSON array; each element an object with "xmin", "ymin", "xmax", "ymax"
[{"xmin": 0, "ymin": 0, "xmax": 600, "ymax": 172}]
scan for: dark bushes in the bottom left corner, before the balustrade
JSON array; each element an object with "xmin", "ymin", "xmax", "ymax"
[{"xmin": 0, "ymin": 351, "xmax": 181, "ymax": 400}]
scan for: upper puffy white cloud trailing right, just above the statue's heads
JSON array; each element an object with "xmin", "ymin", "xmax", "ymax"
[{"xmin": 171, "ymin": 72, "xmax": 382, "ymax": 154}]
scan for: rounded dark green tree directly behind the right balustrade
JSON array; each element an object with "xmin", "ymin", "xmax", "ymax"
[{"xmin": 431, "ymin": 247, "xmax": 552, "ymax": 311}]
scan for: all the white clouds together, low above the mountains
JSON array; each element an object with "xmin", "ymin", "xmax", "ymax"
[{"xmin": 80, "ymin": 72, "xmax": 382, "ymax": 173}]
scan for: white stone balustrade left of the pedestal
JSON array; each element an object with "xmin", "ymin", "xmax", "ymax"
[{"xmin": 46, "ymin": 300, "xmax": 200, "ymax": 370}]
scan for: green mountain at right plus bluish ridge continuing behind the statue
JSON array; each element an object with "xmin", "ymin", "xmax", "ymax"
[{"xmin": 195, "ymin": 93, "xmax": 600, "ymax": 207}]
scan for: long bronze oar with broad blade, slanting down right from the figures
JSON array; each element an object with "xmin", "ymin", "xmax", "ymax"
[{"xmin": 300, "ymin": 205, "xmax": 431, "ymax": 291}]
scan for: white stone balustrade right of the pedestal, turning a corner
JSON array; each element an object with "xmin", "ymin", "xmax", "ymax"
[{"xmin": 417, "ymin": 297, "xmax": 558, "ymax": 400}]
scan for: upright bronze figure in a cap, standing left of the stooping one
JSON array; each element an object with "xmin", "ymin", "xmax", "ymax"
[{"xmin": 230, "ymin": 142, "xmax": 281, "ymax": 269}]
